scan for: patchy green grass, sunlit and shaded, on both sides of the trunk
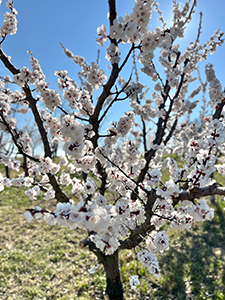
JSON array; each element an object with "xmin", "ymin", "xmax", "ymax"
[{"xmin": 0, "ymin": 164, "xmax": 225, "ymax": 300}]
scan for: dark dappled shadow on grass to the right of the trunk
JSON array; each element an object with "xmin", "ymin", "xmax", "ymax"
[{"xmin": 155, "ymin": 201, "xmax": 225, "ymax": 300}]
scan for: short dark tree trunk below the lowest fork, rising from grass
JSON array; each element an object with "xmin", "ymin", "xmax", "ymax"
[{"xmin": 94, "ymin": 251, "xmax": 123, "ymax": 300}]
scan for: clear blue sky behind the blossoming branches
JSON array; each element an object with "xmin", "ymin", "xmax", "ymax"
[{"xmin": 0, "ymin": 0, "xmax": 225, "ymax": 132}]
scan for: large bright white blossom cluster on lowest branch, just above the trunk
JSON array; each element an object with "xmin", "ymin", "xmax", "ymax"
[{"xmin": 25, "ymin": 198, "xmax": 127, "ymax": 255}]
